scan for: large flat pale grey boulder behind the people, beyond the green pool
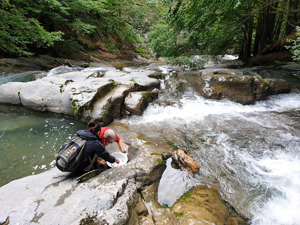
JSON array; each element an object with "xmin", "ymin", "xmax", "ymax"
[{"xmin": 0, "ymin": 70, "xmax": 160, "ymax": 125}]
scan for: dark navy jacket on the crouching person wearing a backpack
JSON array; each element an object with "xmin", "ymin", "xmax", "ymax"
[{"xmin": 76, "ymin": 130, "xmax": 116, "ymax": 163}]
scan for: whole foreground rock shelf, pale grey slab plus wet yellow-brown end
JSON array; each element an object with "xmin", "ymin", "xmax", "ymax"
[{"xmin": 0, "ymin": 123, "xmax": 246, "ymax": 225}]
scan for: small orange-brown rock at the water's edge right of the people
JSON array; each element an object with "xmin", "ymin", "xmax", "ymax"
[{"xmin": 172, "ymin": 148, "xmax": 200, "ymax": 174}]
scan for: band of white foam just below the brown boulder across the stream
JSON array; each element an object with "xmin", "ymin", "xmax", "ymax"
[{"xmin": 125, "ymin": 94, "xmax": 300, "ymax": 123}]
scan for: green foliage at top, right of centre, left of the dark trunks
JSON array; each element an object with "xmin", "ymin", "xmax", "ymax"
[{"xmin": 149, "ymin": 0, "xmax": 241, "ymax": 57}]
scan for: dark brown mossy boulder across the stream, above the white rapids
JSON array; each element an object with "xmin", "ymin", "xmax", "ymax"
[{"xmin": 177, "ymin": 68, "xmax": 290, "ymax": 105}]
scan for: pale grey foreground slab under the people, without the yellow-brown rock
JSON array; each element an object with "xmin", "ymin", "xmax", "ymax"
[{"xmin": 0, "ymin": 141, "xmax": 166, "ymax": 225}]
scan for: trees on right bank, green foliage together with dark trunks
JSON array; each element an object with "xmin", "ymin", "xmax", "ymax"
[{"xmin": 149, "ymin": 0, "xmax": 299, "ymax": 61}]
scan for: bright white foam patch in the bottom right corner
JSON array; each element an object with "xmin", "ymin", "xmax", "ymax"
[{"xmin": 252, "ymin": 154, "xmax": 300, "ymax": 225}]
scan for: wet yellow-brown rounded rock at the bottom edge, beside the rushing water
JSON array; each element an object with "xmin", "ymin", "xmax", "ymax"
[{"xmin": 137, "ymin": 180, "xmax": 247, "ymax": 225}]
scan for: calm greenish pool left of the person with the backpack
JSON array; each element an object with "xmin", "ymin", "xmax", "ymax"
[{"xmin": 0, "ymin": 105, "xmax": 85, "ymax": 186}]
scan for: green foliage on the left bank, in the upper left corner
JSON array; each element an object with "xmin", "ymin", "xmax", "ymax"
[{"xmin": 0, "ymin": 0, "xmax": 152, "ymax": 55}]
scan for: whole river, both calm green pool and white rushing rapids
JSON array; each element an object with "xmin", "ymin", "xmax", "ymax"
[{"xmin": 0, "ymin": 62, "xmax": 300, "ymax": 225}]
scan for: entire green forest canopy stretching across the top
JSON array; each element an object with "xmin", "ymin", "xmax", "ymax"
[{"xmin": 0, "ymin": 0, "xmax": 300, "ymax": 61}]
